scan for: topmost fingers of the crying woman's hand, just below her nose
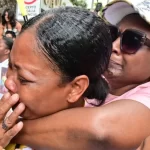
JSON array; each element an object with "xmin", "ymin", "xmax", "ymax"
[{"xmin": 0, "ymin": 93, "xmax": 19, "ymax": 120}]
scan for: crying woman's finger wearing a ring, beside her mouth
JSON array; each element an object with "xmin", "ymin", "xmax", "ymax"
[{"xmin": 5, "ymin": 103, "xmax": 25, "ymax": 129}]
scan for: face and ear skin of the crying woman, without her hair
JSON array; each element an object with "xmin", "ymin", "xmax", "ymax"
[{"xmin": 6, "ymin": 30, "xmax": 88, "ymax": 119}]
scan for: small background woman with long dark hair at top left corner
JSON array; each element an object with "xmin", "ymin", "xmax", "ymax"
[{"xmin": 2, "ymin": 8, "xmax": 22, "ymax": 35}]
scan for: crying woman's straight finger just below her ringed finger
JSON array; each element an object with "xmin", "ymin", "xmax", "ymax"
[{"xmin": 0, "ymin": 122, "xmax": 23, "ymax": 150}]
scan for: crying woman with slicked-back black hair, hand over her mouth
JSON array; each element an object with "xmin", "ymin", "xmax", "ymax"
[{"xmin": 0, "ymin": 7, "xmax": 112, "ymax": 150}]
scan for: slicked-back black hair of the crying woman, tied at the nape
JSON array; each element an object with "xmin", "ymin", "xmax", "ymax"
[{"xmin": 20, "ymin": 7, "xmax": 112, "ymax": 103}]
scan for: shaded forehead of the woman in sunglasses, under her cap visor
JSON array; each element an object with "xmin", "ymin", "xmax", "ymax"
[{"xmin": 118, "ymin": 14, "xmax": 150, "ymax": 37}]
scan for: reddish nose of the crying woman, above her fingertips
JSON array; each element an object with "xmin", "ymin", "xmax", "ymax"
[{"xmin": 5, "ymin": 69, "xmax": 17, "ymax": 94}]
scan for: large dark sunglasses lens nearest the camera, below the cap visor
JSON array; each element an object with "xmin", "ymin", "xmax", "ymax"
[{"xmin": 121, "ymin": 30, "xmax": 143, "ymax": 54}]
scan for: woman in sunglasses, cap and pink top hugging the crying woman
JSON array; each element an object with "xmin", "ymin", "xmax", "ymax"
[{"xmin": 0, "ymin": 0, "xmax": 150, "ymax": 150}]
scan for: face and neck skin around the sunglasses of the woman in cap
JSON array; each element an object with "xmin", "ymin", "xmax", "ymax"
[{"xmin": 106, "ymin": 15, "xmax": 150, "ymax": 96}]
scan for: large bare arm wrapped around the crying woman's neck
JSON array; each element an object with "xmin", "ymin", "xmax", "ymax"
[{"xmin": 15, "ymin": 100, "xmax": 150, "ymax": 150}]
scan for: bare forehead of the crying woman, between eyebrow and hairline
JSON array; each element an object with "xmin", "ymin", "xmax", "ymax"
[{"xmin": 10, "ymin": 30, "xmax": 49, "ymax": 70}]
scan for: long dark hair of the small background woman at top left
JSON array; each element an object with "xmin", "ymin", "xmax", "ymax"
[{"xmin": 2, "ymin": 8, "xmax": 16, "ymax": 29}]
